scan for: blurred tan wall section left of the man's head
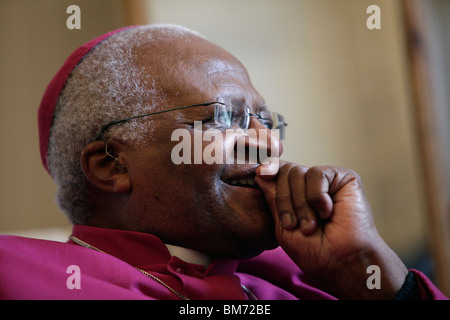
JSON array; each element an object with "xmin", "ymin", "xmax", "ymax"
[{"xmin": 0, "ymin": 0, "xmax": 123, "ymax": 237}]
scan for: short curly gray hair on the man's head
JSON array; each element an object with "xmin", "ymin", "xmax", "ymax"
[{"xmin": 47, "ymin": 25, "xmax": 201, "ymax": 224}]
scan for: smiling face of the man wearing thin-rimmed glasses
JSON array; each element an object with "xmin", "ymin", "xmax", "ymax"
[{"xmin": 128, "ymin": 37, "xmax": 284, "ymax": 258}]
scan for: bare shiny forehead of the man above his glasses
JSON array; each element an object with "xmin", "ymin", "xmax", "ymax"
[{"xmin": 136, "ymin": 35, "xmax": 260, "ymax": 104}]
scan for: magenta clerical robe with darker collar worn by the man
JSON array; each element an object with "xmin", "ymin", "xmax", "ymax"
[{"xmin": 0, "ymin": 226, "xmax": 446, "ymax": 300}]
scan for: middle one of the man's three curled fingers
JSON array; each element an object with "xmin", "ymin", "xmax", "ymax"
[{"xmin": 289, "ymin": 166, "xmax": 317, "ymax": 236}]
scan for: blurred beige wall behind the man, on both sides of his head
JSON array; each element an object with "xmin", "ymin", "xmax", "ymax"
[{"xmin": 0, "ymin": 0, "xmax": 448, "ymax": 294}]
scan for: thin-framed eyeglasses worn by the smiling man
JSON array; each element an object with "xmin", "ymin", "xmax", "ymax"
[{"xmin": 94, "ymin": 101, "xmax": 287, "ymax": 141}]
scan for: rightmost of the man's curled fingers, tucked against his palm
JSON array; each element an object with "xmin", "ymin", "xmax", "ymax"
[{"xmin": 306, "ymin": 167, "xmax": 336, "ymax": 219}]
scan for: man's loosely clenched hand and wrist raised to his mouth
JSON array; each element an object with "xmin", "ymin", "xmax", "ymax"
[{"xmin": 255, "ymin": 162, "xmax": 407, "ymax": 299}]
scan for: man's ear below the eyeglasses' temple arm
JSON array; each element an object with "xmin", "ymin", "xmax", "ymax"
[{"xmin": 81, "ymin": 141, "xmax": 131, "ymax": 193}]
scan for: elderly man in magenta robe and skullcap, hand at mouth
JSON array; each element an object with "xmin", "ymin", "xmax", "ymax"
[{"xmin": 0, "ymin": 25, "xmax": 445, "ymax": 299}]
